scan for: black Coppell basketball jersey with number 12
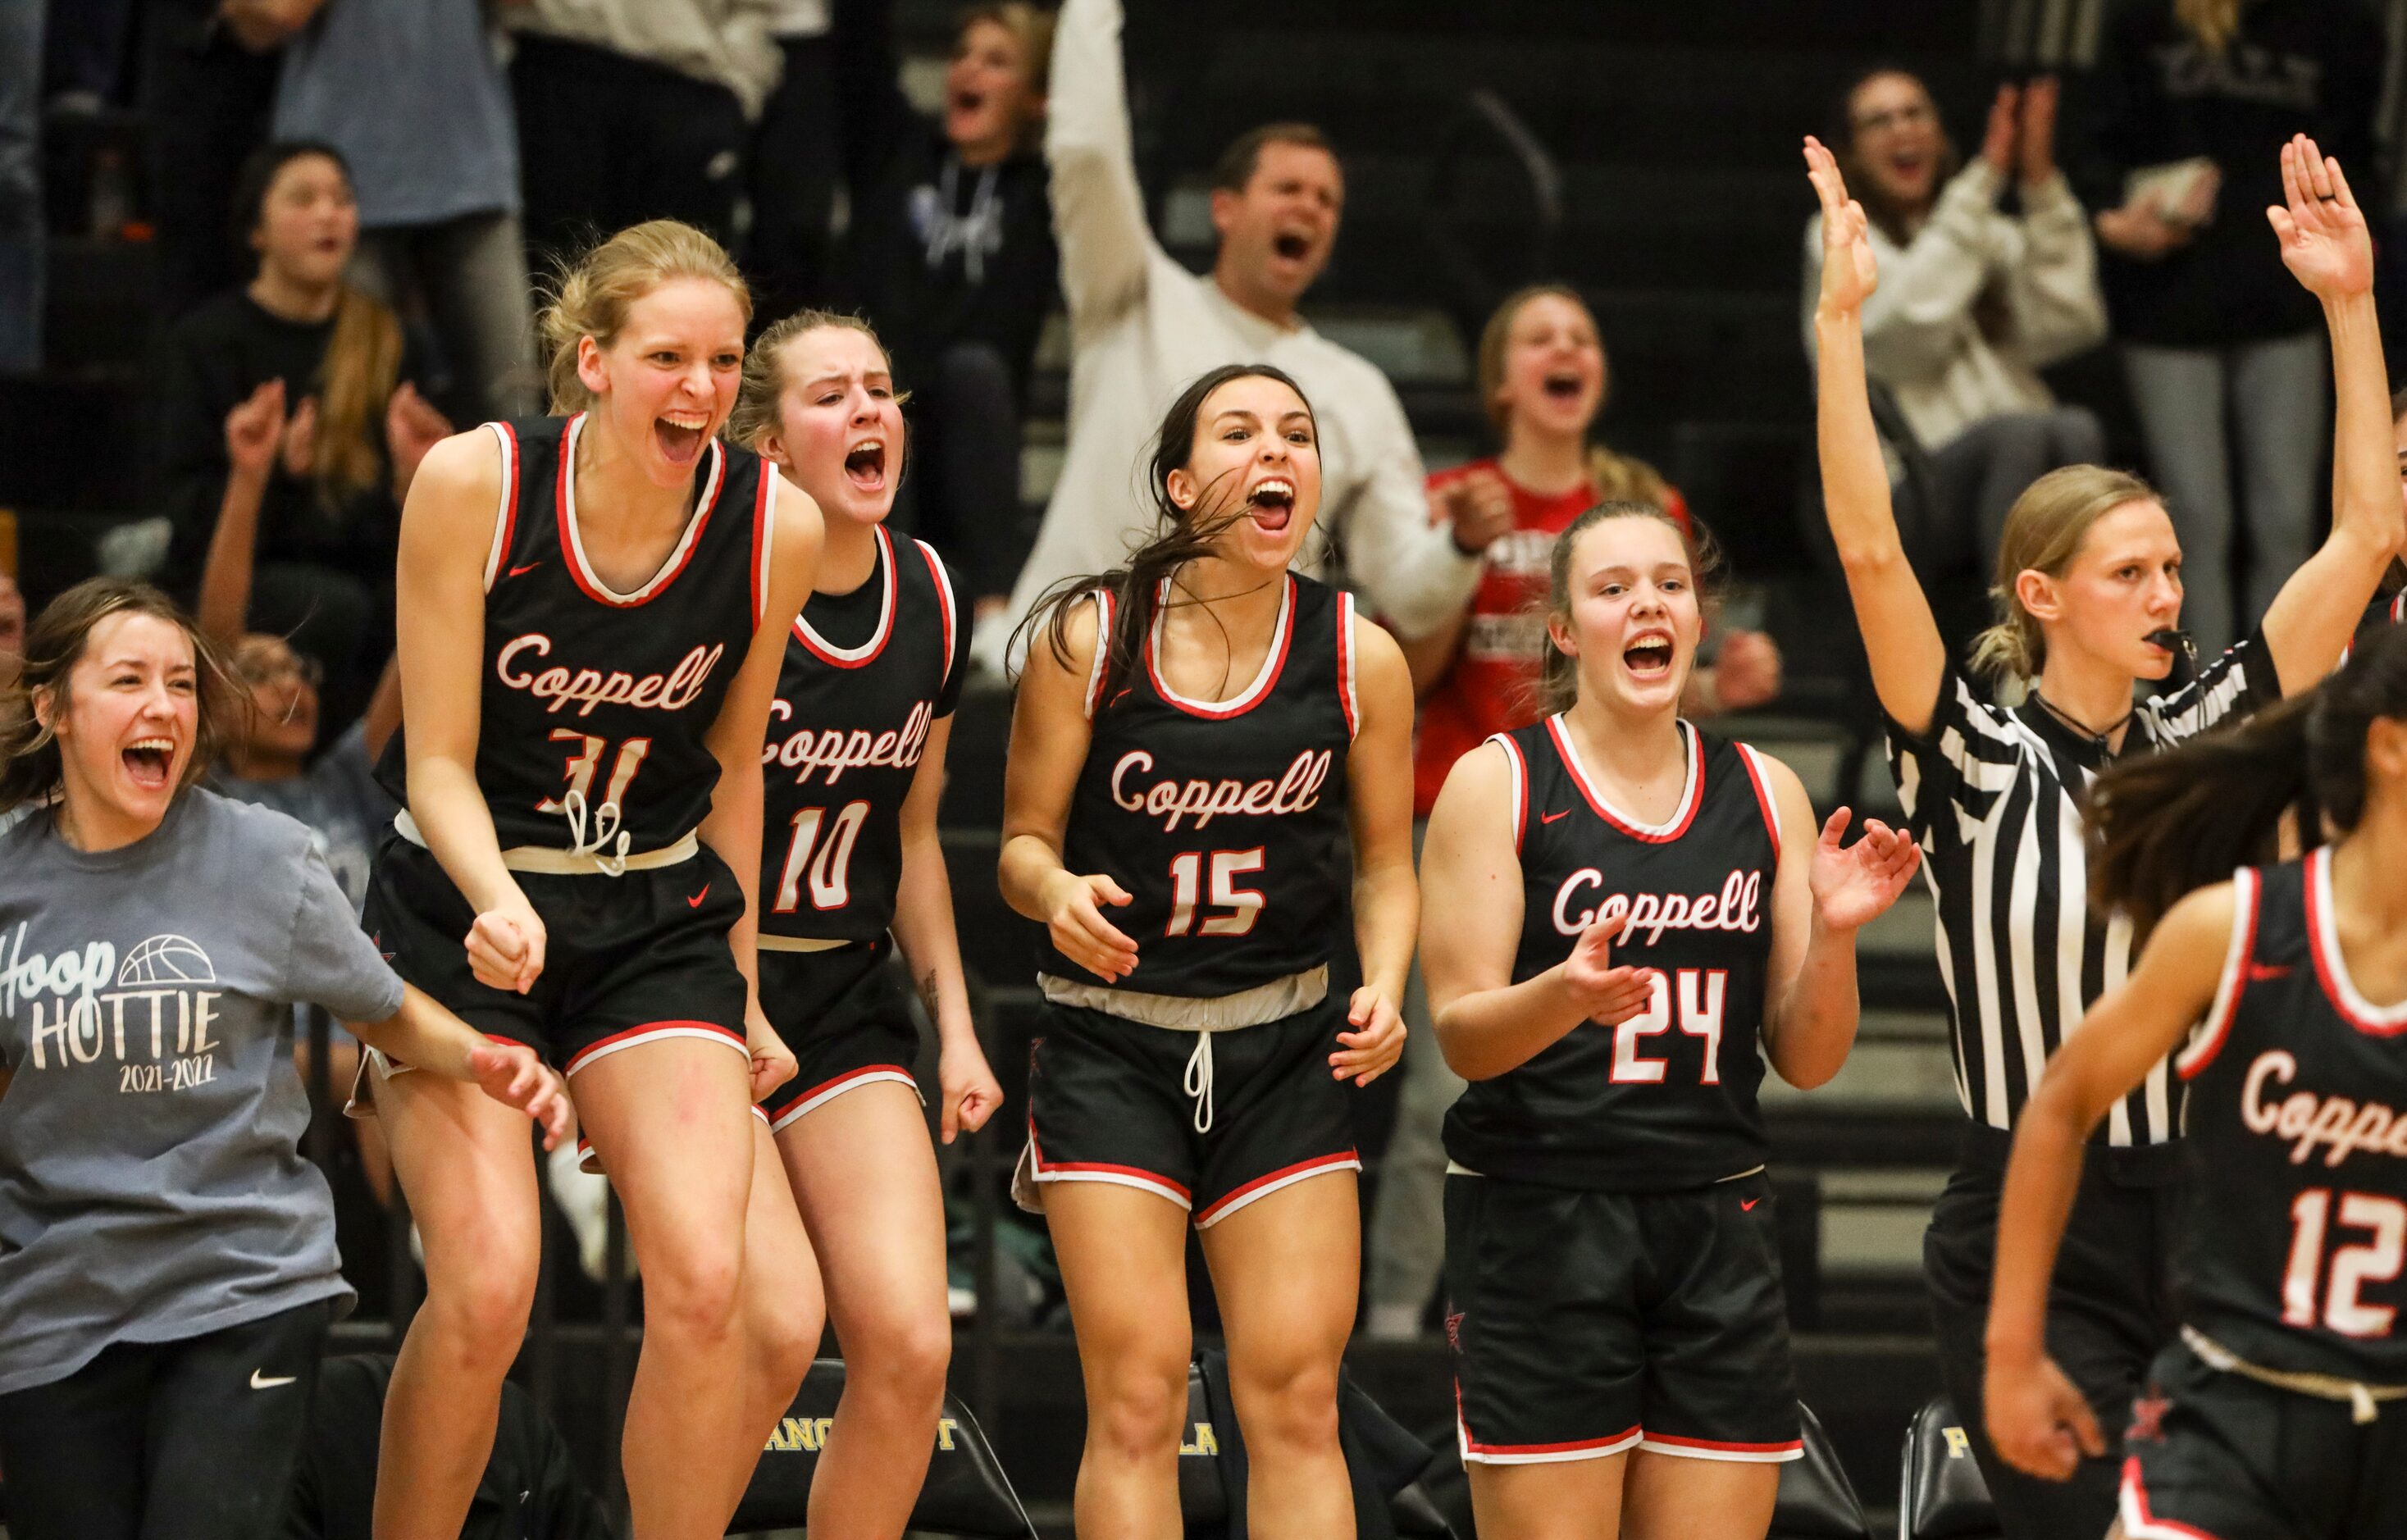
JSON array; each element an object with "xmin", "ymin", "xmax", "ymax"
[{"xmin": 2173, "ymin": 847, "xmax": 2407, "ymax": 1386}]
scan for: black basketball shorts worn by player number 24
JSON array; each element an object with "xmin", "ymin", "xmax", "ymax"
[{"xmin": 1447, "ymin": 1172, "xmax": 1805, "ymax": 1465}]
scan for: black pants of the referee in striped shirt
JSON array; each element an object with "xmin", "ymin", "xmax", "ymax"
[{"xmin": 1923, "ymin": 1126, "xmax": 2181, "ymax": 1540}]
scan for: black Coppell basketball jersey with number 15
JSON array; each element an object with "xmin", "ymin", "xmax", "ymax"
[{"xmin": 1037, "ymin": 575, "xmax": 1360, "ymax": 999}]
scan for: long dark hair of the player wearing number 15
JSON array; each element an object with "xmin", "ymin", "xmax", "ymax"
[{"xmin": 1011, "ymin": 363, "xmax": 1319, "ymax": 710}]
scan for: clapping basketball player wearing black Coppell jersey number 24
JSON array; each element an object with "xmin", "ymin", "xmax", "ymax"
[{"xmin": 1420, "ymin": 503, "xmax": 1918, "ymax": 1540}]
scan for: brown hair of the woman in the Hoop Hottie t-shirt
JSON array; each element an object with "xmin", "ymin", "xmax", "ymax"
[{"xmin": 0, "ymin": 577, "xmax": 243, "ymax": 813}]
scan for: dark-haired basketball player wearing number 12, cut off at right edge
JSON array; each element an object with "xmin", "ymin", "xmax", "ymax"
[{"xmin": 1988, "ymin": 628, "xmax": 2407, "ymax": 1540}]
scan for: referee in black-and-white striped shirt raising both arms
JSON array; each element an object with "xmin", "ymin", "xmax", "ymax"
[{"xmin": 1805, "ymin": 137, "xmax": 2402, "ymax": 1540}]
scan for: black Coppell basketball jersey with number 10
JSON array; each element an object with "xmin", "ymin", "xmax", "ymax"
[{"xmin": 760, "ymin": 527, "xmax": 960, "ymax": 941}]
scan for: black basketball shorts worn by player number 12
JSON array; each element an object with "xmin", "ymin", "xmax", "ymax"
[{"xmin": 2121, "ymin": 1340, "xmax": 2407, "ymax": 1540}]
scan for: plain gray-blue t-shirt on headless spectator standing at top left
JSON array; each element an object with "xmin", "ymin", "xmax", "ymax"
[{"xmin": 275, "ymin": 0, "xmax": 517, "ymax": 231}]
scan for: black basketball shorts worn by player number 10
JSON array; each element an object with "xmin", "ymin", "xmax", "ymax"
[{"xmin": 759, "ymin": 936, "xmax": 919, "ymax": 1128}]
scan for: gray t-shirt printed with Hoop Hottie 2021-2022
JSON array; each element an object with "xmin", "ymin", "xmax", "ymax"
[{"xmin": 0, "ymin": 789, "xmax": 402, "ymax": 1396}]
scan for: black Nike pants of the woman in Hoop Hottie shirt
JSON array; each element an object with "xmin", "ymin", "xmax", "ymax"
[{"xmin": 0, "ymin": 1300, "xmax": 332, "ymax": 1540}]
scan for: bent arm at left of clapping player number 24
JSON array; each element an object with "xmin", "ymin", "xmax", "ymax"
[{"xmin": 1420, "ymin": 741, "xmax": 1661, "ymax": 1081}]
